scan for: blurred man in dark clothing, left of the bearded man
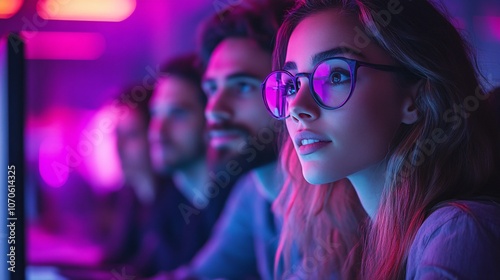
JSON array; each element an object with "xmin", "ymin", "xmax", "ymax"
[{"xmin": 129, "ymin": 55, "xmax": 238, "ymax": 276}]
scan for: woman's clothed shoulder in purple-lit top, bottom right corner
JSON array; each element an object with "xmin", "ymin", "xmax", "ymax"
[{"xmin": 407, "ymin": 199, "xmax": 500, "ymax": 279}]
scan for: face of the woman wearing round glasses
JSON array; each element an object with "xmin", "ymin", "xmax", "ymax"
[{"xmin": 285, "ymin": 10, "xmax": 411, "ymax": 184}]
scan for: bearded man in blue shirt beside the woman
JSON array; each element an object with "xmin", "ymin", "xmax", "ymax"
[{"xmin": 162, "ymin": 2, "xmax": 290, "ymax": 279}]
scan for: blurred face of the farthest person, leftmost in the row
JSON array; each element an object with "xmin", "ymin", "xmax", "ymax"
[{"xmin": 116, "ymin": 109, "xmax": 150, "ymax": 177}]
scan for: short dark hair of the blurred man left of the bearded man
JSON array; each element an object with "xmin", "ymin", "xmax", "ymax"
[{"xmin": 158, "ymin": 53, "xmax": 207, "ymax": 106}]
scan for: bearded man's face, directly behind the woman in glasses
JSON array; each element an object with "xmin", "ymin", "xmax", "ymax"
[{"xmin": 203, "ymin": 38, "xmax": 271, "ymax": 153}]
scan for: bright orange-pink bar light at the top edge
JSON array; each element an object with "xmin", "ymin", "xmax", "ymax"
[{"xmin": 37, "ymin": 0, "xmax": 136, "ymax": 21}]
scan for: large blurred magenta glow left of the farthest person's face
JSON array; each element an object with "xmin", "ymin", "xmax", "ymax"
[{"xmin": 35, "ymin": 106, "xmax": 123, "ymax": 190}]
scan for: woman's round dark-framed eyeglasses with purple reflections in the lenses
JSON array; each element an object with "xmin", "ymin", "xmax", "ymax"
[{"xmin": 262, "ymin": 57, "xmax": 408, "ymax": 119}]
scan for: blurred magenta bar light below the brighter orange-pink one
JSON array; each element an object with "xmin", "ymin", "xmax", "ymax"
[{"xmin": 21, "ymin": 31, "xmax": 106, "ymax": 60}]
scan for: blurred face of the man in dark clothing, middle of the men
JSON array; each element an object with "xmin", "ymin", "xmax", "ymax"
[{"xmin": 149, "ymin": 76, "xmax": 205, "ymax": 172}]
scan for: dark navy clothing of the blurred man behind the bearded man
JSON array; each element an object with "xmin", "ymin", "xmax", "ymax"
[{"xmin": 133, "ymin": 176, "xmax": 232, "ymax": 276}]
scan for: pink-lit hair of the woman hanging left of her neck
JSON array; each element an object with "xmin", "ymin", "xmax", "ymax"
[{"xmin": 273, "ymin": 137, "xmax": 367, "ymax": 279}]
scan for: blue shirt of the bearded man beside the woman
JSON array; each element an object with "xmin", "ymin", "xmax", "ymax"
[{"xmin": 190, "ymin": 171, "xmax": 278, "ymax": 279}]
